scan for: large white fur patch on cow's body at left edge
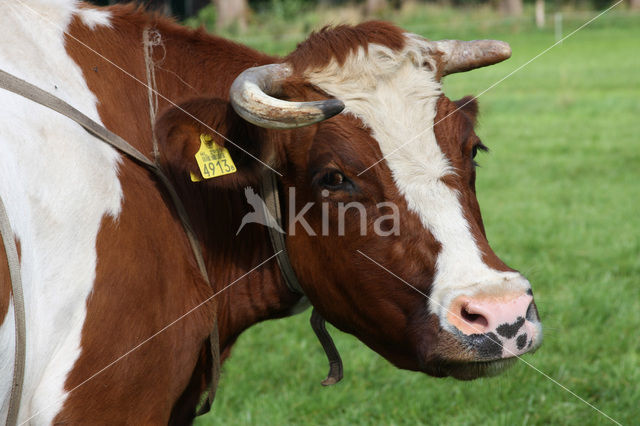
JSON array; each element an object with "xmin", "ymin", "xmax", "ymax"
[{"xmin": 0, "ymin": 0, "xmax": 122, "ymax": 424}]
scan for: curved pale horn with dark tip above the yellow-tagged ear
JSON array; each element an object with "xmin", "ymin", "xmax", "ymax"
[{"xmin": 229, "ymin": 64, "xmax": 344, "ymax": 129}]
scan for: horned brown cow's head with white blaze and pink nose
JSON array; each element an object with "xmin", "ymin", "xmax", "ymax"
[{"xmin": 156, "ymin": 22, "xmax": 542, "ymax": 379}]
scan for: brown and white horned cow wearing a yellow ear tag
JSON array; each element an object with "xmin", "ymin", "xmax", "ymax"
[{"xmin": 0, "ymin": 0, "xmax": 542, "ymax": 424}]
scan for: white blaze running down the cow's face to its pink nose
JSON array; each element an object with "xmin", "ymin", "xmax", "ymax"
[{"xmin": 305, "ymin": 34, "xmax": 529, "ymax": 330}]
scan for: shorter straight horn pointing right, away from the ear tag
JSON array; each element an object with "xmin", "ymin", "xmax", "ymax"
[{"xmin": 433, "ymin": 40, "xmax": 511, "ymax": 77}]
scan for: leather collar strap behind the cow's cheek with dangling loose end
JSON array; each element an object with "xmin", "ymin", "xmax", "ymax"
[{"xmin": 260, "ymin": 172, "xmax": 343, "ymax": 386}]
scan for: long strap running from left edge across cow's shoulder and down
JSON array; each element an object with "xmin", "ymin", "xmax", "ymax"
[{"xmin": 0, "ymin": 70, "xmax": 220, "ymax": 415}]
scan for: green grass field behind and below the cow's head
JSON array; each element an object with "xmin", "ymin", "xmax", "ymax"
[{"xmin": 192, "ymin": 9, "xmax": 640, "ymax": 425}]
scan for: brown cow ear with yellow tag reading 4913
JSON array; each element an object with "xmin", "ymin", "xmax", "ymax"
[{"xmin": 155, "ymin": 98, "xmax": 275, "ymax": 189}]
